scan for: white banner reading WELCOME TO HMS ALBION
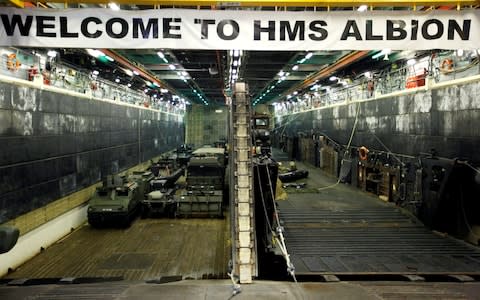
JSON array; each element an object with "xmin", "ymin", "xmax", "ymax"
[{"xmin": 0, "ymin": 7, "xmax": 480, "ymax": 51}]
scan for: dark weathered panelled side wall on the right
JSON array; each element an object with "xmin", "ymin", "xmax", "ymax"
[{"xmin": 276, "ymin": 82, "xmax": 480, "ymax": 162}]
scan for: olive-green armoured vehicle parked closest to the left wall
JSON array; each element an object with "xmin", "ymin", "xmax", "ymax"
[{"xmin": 87, "ymin": 172, "xmax": 153, "ymax": 227}]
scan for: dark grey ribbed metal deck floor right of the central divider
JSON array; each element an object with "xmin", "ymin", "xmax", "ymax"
[{"xmin": 278, "ymin": 164, "xmax": 480, "ymax": 276}]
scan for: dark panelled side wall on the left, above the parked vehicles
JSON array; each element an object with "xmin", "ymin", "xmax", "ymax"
[{"xmin": 0, "ymin": 83, "xmax": 184, "ymax": 223}]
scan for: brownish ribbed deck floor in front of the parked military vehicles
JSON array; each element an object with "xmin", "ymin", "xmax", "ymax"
[{"xmin": 6, "ymin": 218, "xmax": 230, "ymax": 280}]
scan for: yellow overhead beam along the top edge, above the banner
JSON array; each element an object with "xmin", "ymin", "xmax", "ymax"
[{"xmin": 13, "ymin": 0, "xmax": 480, "ymax": 8}]
